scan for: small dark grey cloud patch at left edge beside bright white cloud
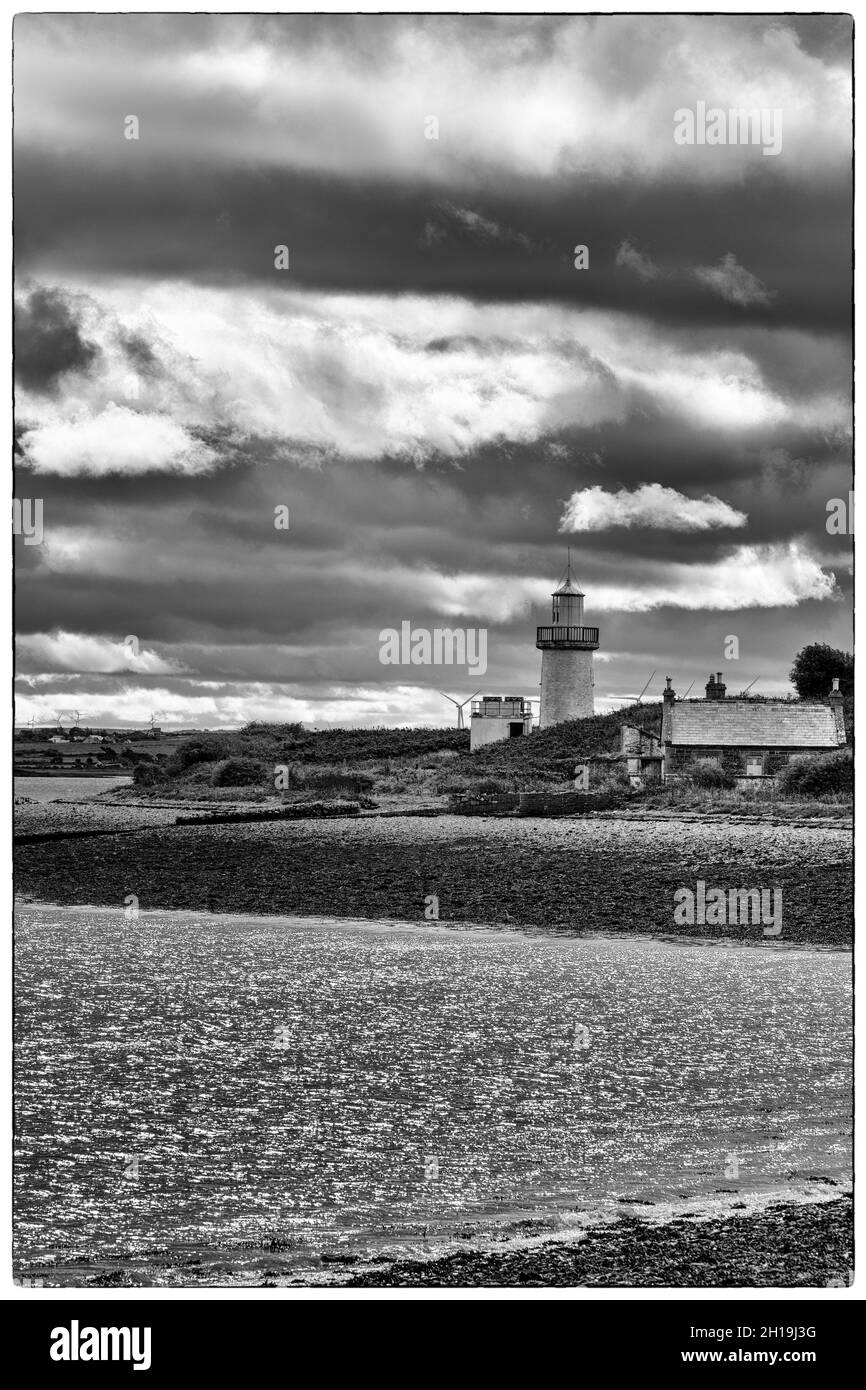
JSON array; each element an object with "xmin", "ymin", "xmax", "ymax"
[{"xmin": 15, "ymin": 288, "xmax": 99, "ymax": 391}]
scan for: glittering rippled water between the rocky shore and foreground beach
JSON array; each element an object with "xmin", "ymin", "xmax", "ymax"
[{"xmin": 15, "ymin": 908, "xmax": 851, "ymax": 1283}]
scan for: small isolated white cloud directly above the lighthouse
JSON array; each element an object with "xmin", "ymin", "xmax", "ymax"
[{"xmin": 559, "ymin": 482, "xmax": 748, "ymax": 531}]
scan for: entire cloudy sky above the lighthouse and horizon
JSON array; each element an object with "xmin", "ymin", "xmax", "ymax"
[{"xmin": 14, "ymin": 14, "xmax": 852, "ymax": 728}]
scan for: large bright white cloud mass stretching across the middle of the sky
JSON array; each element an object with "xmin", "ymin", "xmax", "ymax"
[{"xmin": 13, "ymin": 282, "xmax": 849, "ymax": 474}]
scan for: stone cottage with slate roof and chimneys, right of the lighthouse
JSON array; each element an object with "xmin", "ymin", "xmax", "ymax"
[{"xmin": 662, "ymin": 673, "xmax": 845, "ymax": 790}]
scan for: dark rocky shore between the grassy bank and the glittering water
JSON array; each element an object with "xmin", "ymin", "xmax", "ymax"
[{"xmin": 15, "ymin": 808, "xmax": 852, "ymax": 947}]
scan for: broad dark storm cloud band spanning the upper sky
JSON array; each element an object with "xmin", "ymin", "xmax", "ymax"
[{"xmin": 17, "ymin": 153, "xmax": 851, "ymax": 332}]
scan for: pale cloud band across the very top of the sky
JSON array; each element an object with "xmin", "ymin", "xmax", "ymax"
[{"xmin": 15, "ymin": 15, "xmax": 851, "ymax": 186}]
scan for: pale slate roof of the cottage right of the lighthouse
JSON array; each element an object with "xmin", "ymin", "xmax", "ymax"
[{"xmin": 670, "ymin": 699, "xmax": 840, "ymax": 748}]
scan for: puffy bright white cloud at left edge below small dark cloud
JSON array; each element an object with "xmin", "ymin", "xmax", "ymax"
[{"xmin": 21, "ymin": 403, "xmax": 217, "ymax": 477}]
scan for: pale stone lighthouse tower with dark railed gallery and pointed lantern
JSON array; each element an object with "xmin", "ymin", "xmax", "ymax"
[{"xmin": 535, "ymin": 550, "xmax": 598, "ymax": 728}]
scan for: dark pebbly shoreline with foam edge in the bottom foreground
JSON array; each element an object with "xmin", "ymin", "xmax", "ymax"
[{"xmin": 20, "ymin": 1183, "xmax": 853, "ymax": 1289}]
